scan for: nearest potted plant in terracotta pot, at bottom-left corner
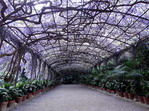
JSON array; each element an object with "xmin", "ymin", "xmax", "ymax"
[{"xmin": 0, "ymin": 88, "xmax": 10, "ymax": 111}]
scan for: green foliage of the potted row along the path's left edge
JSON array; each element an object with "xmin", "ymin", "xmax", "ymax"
[{"xmin": 0, "ymin": 80, "xmax": 58, "ymax": 102}]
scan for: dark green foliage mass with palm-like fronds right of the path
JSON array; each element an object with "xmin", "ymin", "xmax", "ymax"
[{"xmin": 79, "ymin": 45, "xmax": 149, "ymax": 97}]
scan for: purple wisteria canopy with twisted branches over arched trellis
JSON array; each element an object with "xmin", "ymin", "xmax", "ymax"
[{"xmin": 0, "ymin": 0, "xmax": 149, "ymax": 80}]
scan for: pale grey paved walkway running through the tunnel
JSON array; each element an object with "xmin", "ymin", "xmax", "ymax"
[{"xmin": 11, "ymin": 85, "xmax": 149, "ymax": 111}]
